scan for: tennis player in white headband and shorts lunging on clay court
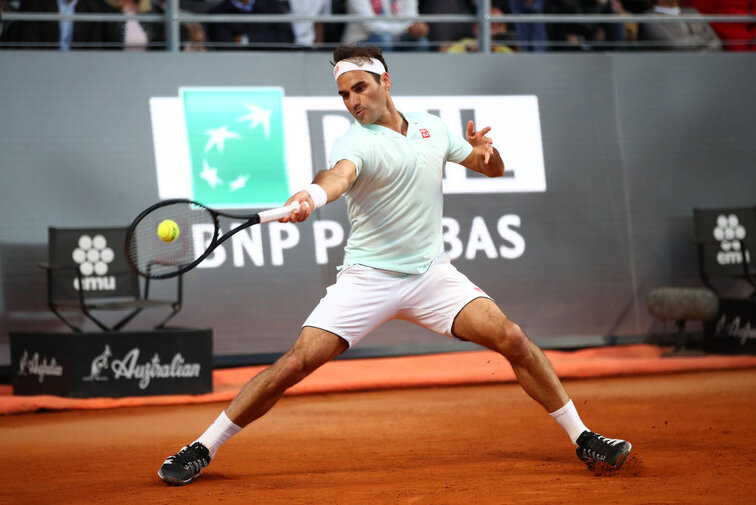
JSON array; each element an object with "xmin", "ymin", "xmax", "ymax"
[{"xmin": 158, "ymin": 46, "xmax": 631, "ymax": 485}]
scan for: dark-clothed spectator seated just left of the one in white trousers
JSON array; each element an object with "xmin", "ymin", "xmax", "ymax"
[{"xmin": 205, "ymin": 0, "xmax": 294, "ymax": 50}]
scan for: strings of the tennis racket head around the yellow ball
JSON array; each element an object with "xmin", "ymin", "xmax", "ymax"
[{"xmin": 126, "ymin": 202, "xmax": 217, "ymax": 278}]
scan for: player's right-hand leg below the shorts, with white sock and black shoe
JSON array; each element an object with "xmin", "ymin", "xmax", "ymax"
[{"xmin": 452, "ymin": 298, "xmax": 632, "ymax": 468}]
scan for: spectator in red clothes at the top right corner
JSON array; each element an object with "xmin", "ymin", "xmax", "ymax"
[{"xmin": 690, "ymin": 0, "xmax": 756, "ymax": 51}]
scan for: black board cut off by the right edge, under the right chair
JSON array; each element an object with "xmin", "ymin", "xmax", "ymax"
[{"xmin": 704, "ymin": 298, "xmax": 756, "ymax": 354}]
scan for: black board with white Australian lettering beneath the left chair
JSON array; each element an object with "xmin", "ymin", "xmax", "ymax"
[{"xmin": 10, "ymin": 329, "xmax": 213, "ymax": 398}]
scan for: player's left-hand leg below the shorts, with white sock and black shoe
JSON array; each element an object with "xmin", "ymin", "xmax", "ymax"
[{"xmin": 158, "ymin": 326, "xmax": 348, "ymax": 486}]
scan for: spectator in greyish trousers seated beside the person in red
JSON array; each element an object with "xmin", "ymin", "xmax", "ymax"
[{"xmin": 639, "ymin": 0, "xmax": 722, "ymax": 51}]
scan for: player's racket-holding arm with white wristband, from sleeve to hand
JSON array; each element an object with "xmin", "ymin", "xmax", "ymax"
[{"xmin": 280, "ymin": 160, "xmax": 357, "ymax": 223}]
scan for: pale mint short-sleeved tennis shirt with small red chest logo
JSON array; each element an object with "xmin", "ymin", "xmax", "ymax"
[{"xmin": 328, "ymin": 113, "xmax": 472, "ymax": 274}]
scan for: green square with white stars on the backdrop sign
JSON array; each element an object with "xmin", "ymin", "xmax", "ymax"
[{"xmin": 180, "ymin": 88, "xmax": 289, "ymax": 207}]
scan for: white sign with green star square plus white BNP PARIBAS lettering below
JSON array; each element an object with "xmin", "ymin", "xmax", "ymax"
[{"xmin": 150, "ymin": 87, "xmax": 546, "ymax": 268}]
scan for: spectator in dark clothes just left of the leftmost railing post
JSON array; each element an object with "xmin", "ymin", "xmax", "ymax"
[{"xmin": 103, "ymin": 0, "xmax": 165, "ymax": 51}]
